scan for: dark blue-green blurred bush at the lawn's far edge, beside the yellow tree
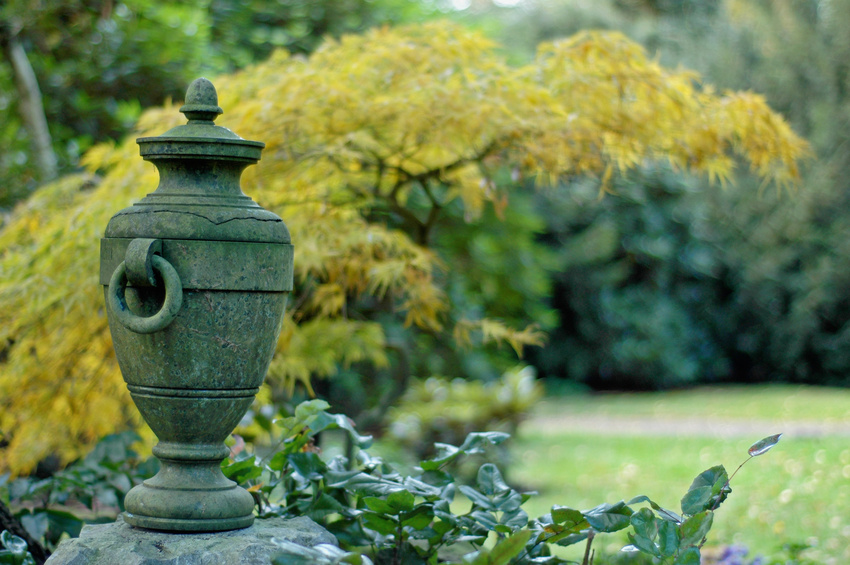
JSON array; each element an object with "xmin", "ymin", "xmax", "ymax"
[{"xmin": 533, "ymin": 167, "xmax": 732, "ymax": 388}]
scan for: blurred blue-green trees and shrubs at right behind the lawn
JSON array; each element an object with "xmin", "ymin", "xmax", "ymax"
[{"xmin": 480, "ymin": 0, "xmax": 850, "ymax": 389}]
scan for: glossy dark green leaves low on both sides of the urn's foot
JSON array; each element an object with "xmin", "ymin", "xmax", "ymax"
[{"xmin": 0, "ymin": 400, "xmax": 781, "ymax": 565}]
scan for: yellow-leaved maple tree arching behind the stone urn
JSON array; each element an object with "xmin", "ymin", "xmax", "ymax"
[{"xmin": 0, "ymin": 23, "xmax": 806, "ymax": 474}]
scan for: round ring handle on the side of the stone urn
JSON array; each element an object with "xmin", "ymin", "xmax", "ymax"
[{"xmin": 106, "ymin": 255, "xmax": 183, "ymax": 334}]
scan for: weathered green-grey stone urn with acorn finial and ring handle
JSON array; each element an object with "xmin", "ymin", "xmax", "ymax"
[{"xmin": 100, "ymin": 78, "xmax": 293, "ymax": 532}]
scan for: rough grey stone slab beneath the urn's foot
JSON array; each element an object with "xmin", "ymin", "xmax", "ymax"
[{"xmin": 47, "ymin": 516, "xmax": 338, "ymax": 565}]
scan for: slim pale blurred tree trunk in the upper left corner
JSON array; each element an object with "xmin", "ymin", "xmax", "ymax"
[{"xmin": 2, "ymin": 28, "xmax": 57, "ymax": 182}]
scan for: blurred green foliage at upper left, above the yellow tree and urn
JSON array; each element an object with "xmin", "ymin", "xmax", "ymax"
[{"xmin": 0, "ymin": 0, "xmax": 429, "ymax": 208}]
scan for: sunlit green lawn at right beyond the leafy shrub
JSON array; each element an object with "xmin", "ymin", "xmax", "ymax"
[{"xmin": 510, "ymin": 387, "xmax": 850, "ymax": 565}]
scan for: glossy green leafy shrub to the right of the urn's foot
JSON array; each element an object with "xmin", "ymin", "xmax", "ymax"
[{"xmin": 223, "ymin": 401, "xmax": 779, "ymax": 565}]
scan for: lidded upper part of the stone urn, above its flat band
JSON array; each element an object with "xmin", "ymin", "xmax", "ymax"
[{"xmin": 105, "ymin": 78, "xmax": 290, "ymax": 243}]
